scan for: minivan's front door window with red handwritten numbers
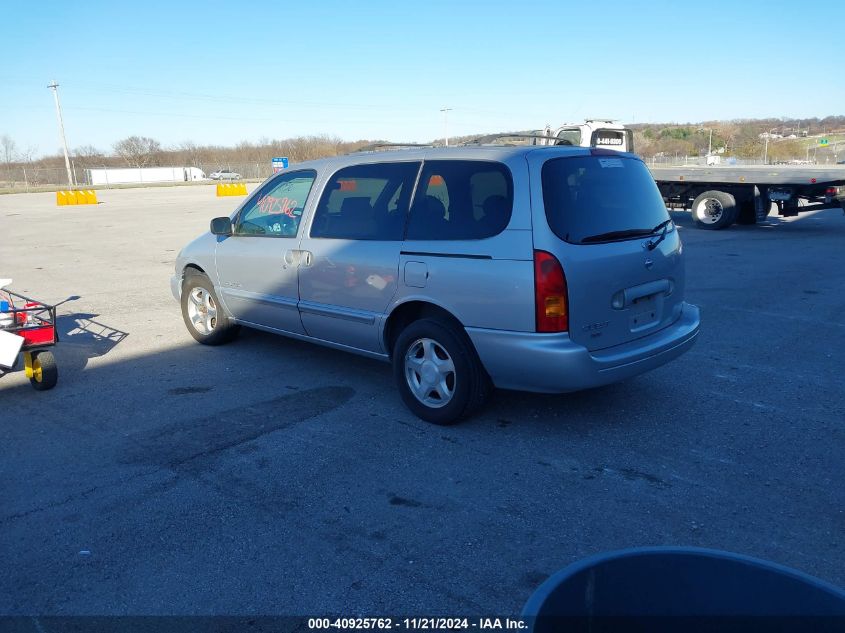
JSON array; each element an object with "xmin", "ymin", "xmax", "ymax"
[{"xmin": 233, "ymin": 170, "xmax": 317, "ymax": 237}]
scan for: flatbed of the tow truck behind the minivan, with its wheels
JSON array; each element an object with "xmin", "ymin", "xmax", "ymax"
[{"xmin": 650, "ymin": 165, "xmax": 845, "ymax": 230}]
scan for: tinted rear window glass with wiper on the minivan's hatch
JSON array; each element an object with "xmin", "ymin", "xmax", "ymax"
[{"xmin": 542, "ymin": 154, "xmax": 672, "ymax": 244}]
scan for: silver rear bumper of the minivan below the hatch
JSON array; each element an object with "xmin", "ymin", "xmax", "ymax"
[{"xmin": 466, "ymin": 303, "xmax": 700, "ymax": 393}]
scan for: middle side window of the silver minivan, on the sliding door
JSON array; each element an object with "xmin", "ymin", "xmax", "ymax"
[{"xmin": 311, "ymin": 162, "xmax": 420, "ymax": 241}]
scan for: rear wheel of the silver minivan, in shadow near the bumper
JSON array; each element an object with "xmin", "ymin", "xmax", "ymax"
[{"xmin": 393, "ymin": 319, "xmax": 492, "ymax": 426}]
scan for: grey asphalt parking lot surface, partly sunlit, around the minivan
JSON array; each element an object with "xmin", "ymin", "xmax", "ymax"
[{"xmin": 0, "ymin": 185, "xmax": 845, "ymax": 615}]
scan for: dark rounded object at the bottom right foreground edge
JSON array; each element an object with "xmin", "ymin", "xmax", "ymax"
[{"xmin": 522, "ymin": 547, "xmax": 845, "ymax": 633}]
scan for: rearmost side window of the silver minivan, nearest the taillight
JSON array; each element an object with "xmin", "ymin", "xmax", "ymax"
[{"xmin": 405, "ymin": 160, "xmax": 513, "ymax": 240}]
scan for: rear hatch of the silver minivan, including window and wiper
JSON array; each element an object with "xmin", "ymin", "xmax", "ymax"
[{"xmin": 532, "ymin": 149, "xmax": 683, "ymax": 350}]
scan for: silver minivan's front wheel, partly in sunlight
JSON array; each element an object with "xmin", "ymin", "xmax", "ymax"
[{"xmin": 182, "ymin": 274, "xmax": 240, "ymax": 345}]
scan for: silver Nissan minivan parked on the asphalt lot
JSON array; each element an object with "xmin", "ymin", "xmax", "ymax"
[{"xmin": 171, "ymin": 146, "xmax": 699, "ymax": 424}]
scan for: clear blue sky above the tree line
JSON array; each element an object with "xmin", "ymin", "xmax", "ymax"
[{"xmin": 0, "ymin": 0, "xmax": 845, "ymax": 155}]
